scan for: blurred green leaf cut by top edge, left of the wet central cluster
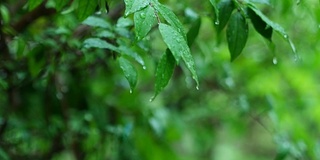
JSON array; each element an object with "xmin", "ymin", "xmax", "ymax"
[{"xmin": 76, "ymin": 0, "xmax": 98, "ymax": 21}]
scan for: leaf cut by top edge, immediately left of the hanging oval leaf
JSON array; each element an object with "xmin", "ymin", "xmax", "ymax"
[{"xmin": 214, "ymin": 0, "xmax": 235, "ymax": 33}]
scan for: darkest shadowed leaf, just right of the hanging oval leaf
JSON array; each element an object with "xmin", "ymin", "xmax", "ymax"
[{"xmin": 248, "ymin": 8, "xmax": 273, "ymax": 41}]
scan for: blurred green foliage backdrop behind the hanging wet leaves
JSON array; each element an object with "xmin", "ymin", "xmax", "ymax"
[{"xmin": 0, "ymin": 0, "xmax": 320, "ymax": 160}]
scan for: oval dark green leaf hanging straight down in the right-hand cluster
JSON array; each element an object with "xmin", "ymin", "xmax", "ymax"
[{"xmin": 227, "ymin": 12, "xmax": 248, "ymax": 61}]
